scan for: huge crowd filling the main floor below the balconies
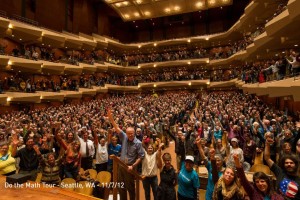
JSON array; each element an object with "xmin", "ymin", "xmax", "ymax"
[{"xmin": 0, "ymin": 91, "xmax": 300, "ymax": 200}]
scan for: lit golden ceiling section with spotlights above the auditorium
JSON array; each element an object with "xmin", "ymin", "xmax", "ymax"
[{"xmin": 103, "ymin": 0, "xmax": 232, "ymax": 21}]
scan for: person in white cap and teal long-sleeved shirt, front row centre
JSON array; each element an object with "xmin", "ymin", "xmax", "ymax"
[{"xmin": 178, "ymin": 155, "xmax": 200, "ymax": 200}]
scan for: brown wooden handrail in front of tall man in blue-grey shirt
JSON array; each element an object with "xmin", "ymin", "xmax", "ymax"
[{"xmin": 110, "ymin": 155, "xmax": 145, "ymax": 200}]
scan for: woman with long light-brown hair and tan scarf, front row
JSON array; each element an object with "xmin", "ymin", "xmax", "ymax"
[{"xmin": 212, "ymin": 167, "xmax": 244, "ymax": 200}]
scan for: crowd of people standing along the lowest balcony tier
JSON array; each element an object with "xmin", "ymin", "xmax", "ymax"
[{"xmin": 0, "ymin": 49, "xmax": 300, "ymax": 93}]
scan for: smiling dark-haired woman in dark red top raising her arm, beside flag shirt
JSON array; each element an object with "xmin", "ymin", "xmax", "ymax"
[{"xmin": 233, "ymin": 154, "xmax": 284, "ymax": 200}]
